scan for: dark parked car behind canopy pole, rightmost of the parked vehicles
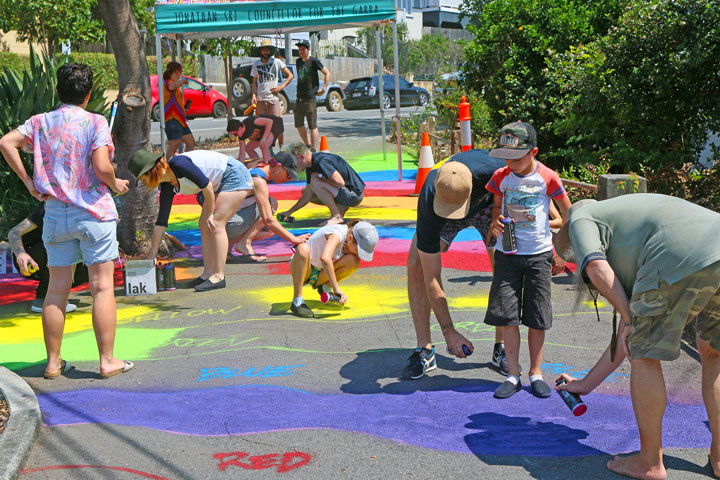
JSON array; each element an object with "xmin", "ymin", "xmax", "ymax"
[{"xmin": 345, "ymin": 75, "xmax": 430, "ymax": 110}]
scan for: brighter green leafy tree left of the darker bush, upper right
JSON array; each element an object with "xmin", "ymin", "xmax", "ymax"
[{"xmin": 462, "ymin": 0, "xmax": 622, "ymax": 165}]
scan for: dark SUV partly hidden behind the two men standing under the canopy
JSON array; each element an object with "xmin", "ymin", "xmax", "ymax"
[{"xmin": 229, "ymin": 63, "xmax": 345, "ymax": 116}]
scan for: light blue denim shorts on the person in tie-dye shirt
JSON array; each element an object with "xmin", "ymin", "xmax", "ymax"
[{"xmin": 43, "ymin": 198, "xmax": 118, "ymax": 267}]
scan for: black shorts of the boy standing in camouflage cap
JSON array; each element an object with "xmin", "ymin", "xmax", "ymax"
[{"xmin": 485, "ymin": 250, "xmax": 552, "ymax": 330}]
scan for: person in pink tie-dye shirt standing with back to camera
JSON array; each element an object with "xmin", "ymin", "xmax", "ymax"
[{"xmin": 0, "ymin": 63, "xmax": 134, "ymax": 378}]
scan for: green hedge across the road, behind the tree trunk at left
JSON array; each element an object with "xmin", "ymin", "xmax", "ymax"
[{"xmin": 0, "ymin": 52, "xmax": 199, "ymax": 90}]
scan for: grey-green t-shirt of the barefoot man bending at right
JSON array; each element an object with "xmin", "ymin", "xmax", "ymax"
[{"xmin": 569, "ymin": 193, "xmax": 720, "ymax": 296}]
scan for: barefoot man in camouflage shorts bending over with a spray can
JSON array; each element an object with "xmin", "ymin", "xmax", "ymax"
[{"xmin": 555, "ymin": 193, "xmax": 720, "ymax": 478}]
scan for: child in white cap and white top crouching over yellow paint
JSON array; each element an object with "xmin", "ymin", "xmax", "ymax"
[{"xmin": 290, "ymin": 220, "xmax": 378, "ymax": 318}]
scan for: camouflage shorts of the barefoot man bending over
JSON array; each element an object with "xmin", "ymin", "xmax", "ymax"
[{"xmin": 628, "ymin": 262, "xmax": 720, "ymax": 360}]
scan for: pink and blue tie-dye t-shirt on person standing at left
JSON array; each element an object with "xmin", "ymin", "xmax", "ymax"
[{"xmin": 17, "ymin": 105, "xmax": 118, "ymax": 221}]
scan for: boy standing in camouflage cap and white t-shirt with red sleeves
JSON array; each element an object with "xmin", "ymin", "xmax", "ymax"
[{"xmin": 485, "ymin": 122, "xmax": 570, "ymax": 398}]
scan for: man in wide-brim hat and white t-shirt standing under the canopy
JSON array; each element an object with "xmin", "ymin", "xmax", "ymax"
[{"xmin": 250, "ymin": 38, "xmax": 293, "ymax": 147}]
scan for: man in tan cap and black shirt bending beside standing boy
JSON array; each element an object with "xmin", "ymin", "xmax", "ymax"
[{"xmin": 402, "ymin": 150, "xmax": 507, "ymax": 380}]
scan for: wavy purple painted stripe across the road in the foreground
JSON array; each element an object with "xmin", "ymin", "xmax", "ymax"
[{"xmin": 38, "ymin": 383, "xmax": 710, "ymax": 457}]
